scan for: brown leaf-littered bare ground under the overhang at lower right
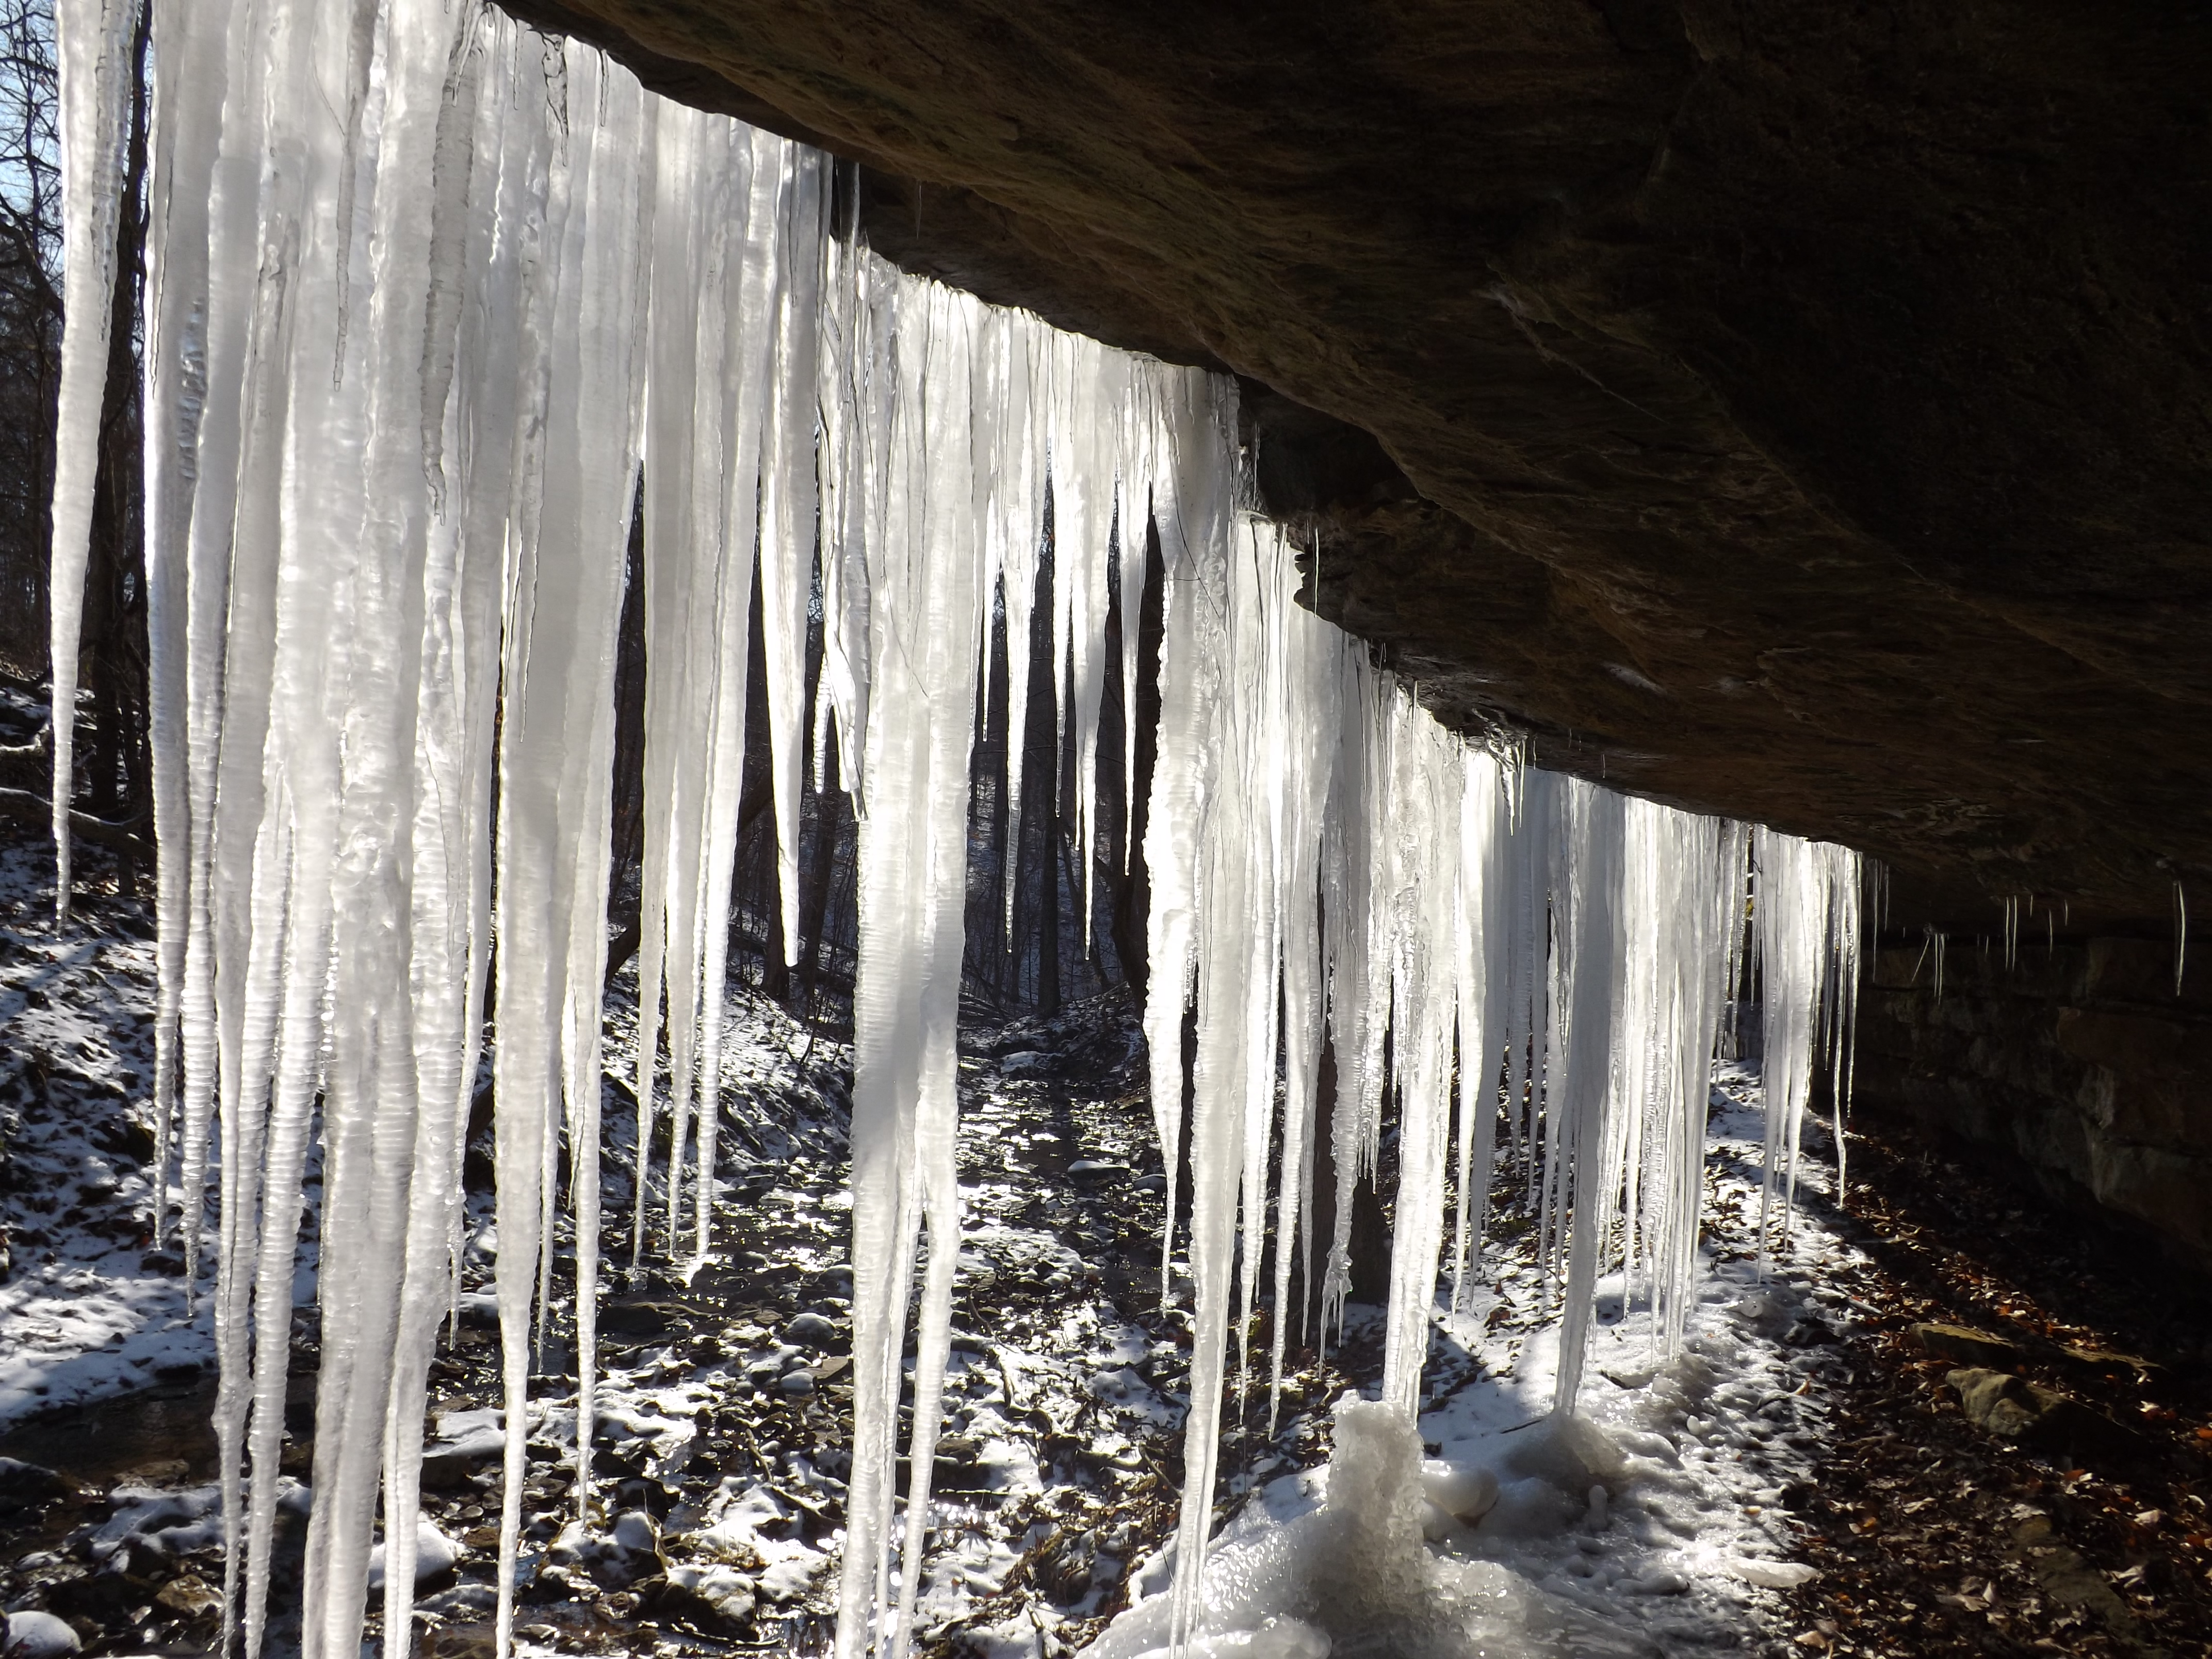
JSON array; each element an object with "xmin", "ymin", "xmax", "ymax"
[{"xmin": 1787, "ymin": 1126, "xmax": 2212, "ymax": 1654}]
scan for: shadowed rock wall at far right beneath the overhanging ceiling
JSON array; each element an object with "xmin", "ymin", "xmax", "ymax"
[{"xmin": 1858, "ymin": 940, "xmax": 2212, "ymax": 1274}]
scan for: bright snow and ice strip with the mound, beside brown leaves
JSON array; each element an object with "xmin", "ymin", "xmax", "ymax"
[{"xmin": 1088, "ymin": 1068, "xmax": 1858, "ymax": 1659}]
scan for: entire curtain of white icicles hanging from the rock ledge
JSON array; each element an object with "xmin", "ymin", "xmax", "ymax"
[{"xmin": 53, "ymin": 0, "xmax": 1858, "ymax": 1659}]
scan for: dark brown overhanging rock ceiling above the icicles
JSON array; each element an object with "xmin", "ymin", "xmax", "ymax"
[{"xmin": 511, "ymin": 0, "xmax": 2212, "ymax": 924}]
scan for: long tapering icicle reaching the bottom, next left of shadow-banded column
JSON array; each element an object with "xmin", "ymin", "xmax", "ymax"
[{"xmin": 496, "ymin": 46, "xmax": 650, "ymax": 1652}]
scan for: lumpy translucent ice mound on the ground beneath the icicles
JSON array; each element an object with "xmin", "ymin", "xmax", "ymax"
[{"xmin": 1088, "ymin": 1400, "xmax": 1648, "ymax": 1659}]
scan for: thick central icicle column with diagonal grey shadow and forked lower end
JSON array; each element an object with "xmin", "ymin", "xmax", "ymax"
[{"xmin": 836, "ymin": 287, "xmax": 982, "ymax": 1659}]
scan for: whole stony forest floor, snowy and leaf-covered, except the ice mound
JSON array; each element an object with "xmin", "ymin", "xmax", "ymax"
[{"xmin": 0, "ymin": 801, "xmax": 2212, "ymax": 1659}]
